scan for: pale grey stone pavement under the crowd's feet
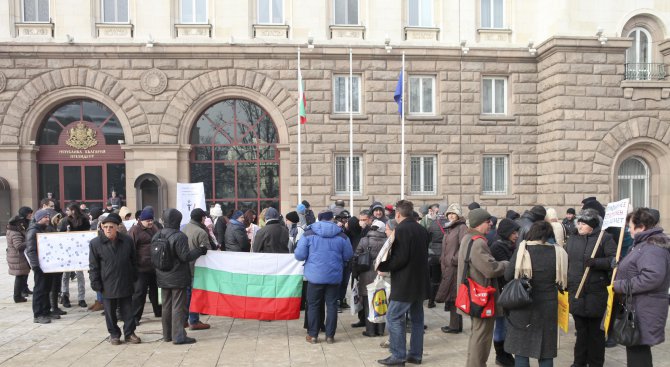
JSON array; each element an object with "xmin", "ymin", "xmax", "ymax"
[{"xmin": 0, "ymin": 237, "xmax": 670, "ymax": 367}]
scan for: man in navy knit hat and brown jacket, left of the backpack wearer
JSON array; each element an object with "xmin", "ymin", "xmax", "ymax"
[{"xmin": 127, "ymin": 206, "xmax": 163, "ymax": 325}]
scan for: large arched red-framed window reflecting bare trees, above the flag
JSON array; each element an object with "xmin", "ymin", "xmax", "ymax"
[{"xmin": 190, "ymin": 99, "xmax": 280, "ymax": 214}]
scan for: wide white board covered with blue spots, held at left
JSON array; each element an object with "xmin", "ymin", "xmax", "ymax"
[{"xmin": 37, "ymin": 231, "xmax": 98, "ymax": 273}]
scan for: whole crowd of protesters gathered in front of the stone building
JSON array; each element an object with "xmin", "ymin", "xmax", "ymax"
[{"xmin": 2, "ymin": 197, "xmax": 670, "ymax": 367}]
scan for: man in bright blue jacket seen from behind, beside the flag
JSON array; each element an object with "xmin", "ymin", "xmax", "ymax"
[{"xmin": 295, "ymin": 210, "xmax": 354, "ymax": 344}]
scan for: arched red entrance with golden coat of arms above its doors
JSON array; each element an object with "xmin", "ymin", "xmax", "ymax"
[{"xmin": 37, "ymin": 99, "xmax": 126, "ymax": 211}]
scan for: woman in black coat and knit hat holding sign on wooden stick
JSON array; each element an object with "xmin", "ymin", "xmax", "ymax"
[{"xmin": 565, "ymin": 209, "xmax": 617, "ymax": 366}]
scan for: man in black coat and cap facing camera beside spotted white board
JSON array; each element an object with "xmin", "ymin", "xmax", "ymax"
[{"xmin": 88, "ymin": 213, "xmax": 142, "ymax": 345}]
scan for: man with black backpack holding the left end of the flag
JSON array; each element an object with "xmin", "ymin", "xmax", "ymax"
[{"xmin": 154, "ymin": 208, "xmax": 207, "ymax": 344}]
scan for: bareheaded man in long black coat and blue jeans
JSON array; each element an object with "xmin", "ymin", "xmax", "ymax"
[{"xmin": 377, "ymin": 200, "xmax": 430, "ymax": 366}]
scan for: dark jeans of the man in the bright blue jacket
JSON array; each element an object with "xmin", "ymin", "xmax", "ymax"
[{"xmin": 307, "ymin": 283, "xmax": 340, "ymax": 338}]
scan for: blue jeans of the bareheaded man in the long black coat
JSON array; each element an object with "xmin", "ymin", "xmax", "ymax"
[{"xmin": 386, "ymin": 300, "xmax": 423, "ymax": 361}]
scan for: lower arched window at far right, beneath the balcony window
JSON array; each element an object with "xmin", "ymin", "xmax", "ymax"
[{"xmin": 618, "ymin": 157, "xmax": 649, "ymax": 208}]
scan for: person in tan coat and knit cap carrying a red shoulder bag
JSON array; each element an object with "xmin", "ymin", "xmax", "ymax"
[{"xmin": 456, "ymin": 208, "xmax": 509, "ymax": 366}]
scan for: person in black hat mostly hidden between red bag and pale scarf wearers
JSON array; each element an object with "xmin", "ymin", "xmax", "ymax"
[{"xmin": 491, "ymin": 218, "xmax": 519, "ymax": 366}]
